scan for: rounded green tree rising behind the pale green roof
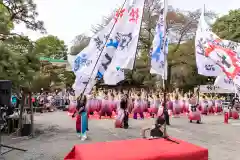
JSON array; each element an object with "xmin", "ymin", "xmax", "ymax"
[{"xmin": 35, "ymin": 35, "xmax": 67, "ymax": 59}]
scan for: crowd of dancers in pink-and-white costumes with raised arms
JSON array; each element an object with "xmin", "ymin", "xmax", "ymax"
[{"xmin": 69, "ymin": 89, "xmax": 239, "ymax": 140}]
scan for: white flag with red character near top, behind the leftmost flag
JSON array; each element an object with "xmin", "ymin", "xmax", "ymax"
[{"xmin": 109, "ymin": 0, "xmax": 145, "ymax": 71}]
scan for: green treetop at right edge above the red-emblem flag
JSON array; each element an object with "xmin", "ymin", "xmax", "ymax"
[{"xmin": 212, "ymin": 9, "xmax": 240, "ymax": 42}]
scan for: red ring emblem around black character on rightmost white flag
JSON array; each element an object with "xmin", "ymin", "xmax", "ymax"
[{"xmin": 205, "ymin": 43, "xmax": 240, "ymax": 79}]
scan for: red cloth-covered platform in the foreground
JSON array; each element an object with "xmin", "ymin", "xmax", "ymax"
[{"xmin": 64, "ymin": 139, "xmax": 208, "ymax": 160}]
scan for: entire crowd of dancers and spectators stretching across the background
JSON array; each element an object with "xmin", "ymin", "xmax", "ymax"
[{"xmin": 8, "ymin": 89, "xmax": 239, "ymax": 139}]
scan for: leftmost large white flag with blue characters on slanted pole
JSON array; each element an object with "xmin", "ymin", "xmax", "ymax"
[{"xmin": 73, "ymin": 0, "xmax": 128, "ymax": 98}]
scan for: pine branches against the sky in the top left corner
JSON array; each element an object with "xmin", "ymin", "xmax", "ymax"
[{"xmin": 0, "ymin": 0, "xmax": 46, "ymax": 41}]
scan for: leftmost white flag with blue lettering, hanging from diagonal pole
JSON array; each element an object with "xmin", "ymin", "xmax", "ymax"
[{"xmin": 73, "ymin": 0, "xmax": 134, "ymax": 93}]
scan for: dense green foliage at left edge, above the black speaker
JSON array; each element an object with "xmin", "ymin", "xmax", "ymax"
[{"xmin": 0, "ymin": 37, "xmax": 40, "ymax": 88}]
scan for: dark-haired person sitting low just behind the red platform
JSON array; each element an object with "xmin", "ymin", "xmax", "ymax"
[{"xmin": 142, "ymin": 116, "xmax": 166, "ymax": 139}]
